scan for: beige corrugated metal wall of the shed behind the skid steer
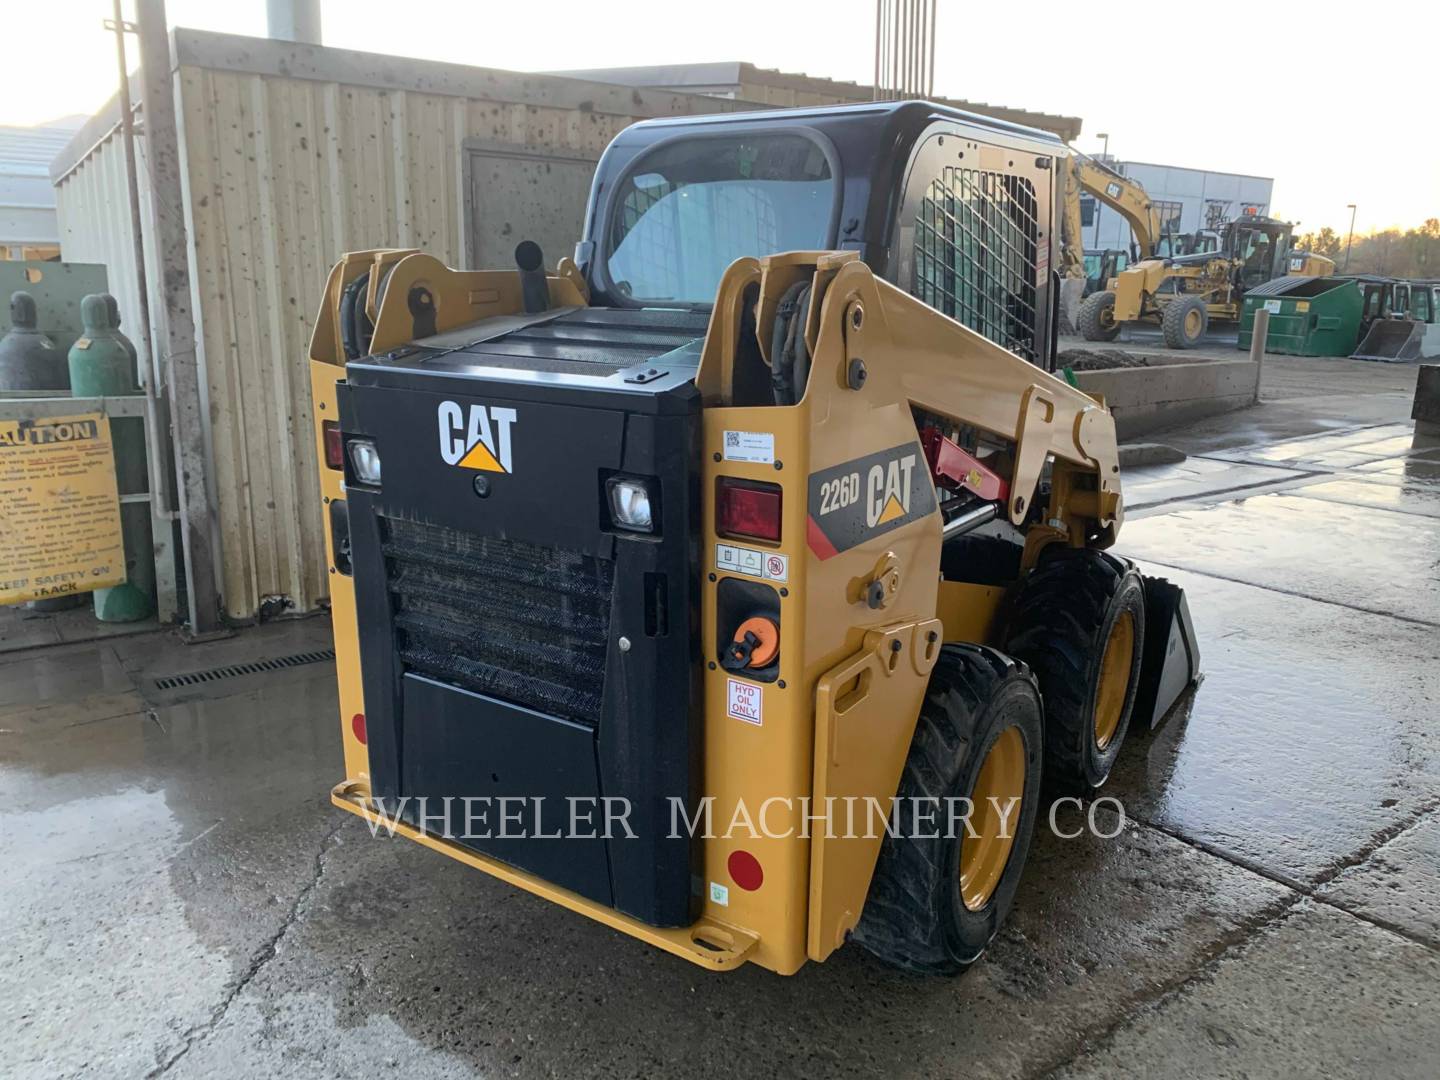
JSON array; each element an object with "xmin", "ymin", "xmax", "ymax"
[{"xmin": 172, "ymin": 68, "xmax": 691, "ymax": 616}]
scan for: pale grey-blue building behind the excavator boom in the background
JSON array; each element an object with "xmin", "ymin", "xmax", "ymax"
[{"xmin": 1080, "ymin": 160, "xmax": 1274, "ymax": 251}]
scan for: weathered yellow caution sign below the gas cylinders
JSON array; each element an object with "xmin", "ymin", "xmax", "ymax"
[{"xmin": 0, "ymin": 413, "xmax": 125, "ymax": 603}]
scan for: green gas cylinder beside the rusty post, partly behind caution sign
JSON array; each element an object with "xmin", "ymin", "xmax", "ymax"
[{"xmin": 69, "ymin": 292, "xmax": 156, "ymax": 622}]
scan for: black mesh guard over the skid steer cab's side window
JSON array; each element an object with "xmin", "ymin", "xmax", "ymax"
[{"xmin": 913, "ymin": 166, "xmax": 1040, "ymax": 361}]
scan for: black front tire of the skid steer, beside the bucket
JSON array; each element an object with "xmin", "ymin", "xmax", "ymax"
[{"xmin": 1005, "ymin": 544, "xmax": 1145, "ymax": 795}]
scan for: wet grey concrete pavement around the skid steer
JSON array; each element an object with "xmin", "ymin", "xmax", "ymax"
[{"xmin": 0, "ymin": 355, "xmax": 1440, "ymax": 1077}]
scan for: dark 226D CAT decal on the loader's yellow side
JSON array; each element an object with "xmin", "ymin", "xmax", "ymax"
[{"xmin": 806, "ymin": 442, "xmax": 935, "ymax": 559}]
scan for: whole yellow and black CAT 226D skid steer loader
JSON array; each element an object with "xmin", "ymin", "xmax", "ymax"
[{"xmin": 311, "ymin": 102, "xmax": 1197, "ymax": 973}]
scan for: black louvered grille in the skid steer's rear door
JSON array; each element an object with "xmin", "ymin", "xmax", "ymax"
[{"xmin": 382, "ymin": 518, "xmax": 615, "ymax": 726}]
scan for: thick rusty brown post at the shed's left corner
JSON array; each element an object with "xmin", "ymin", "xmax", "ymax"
[{"xmin": 135, "ymin": 0, "xmax": 225, "ymax": 638}]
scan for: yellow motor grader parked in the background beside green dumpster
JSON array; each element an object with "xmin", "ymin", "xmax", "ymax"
[{"xmin": 1077, "ymin": 215, "xmax": 1335, "ymax": 348}]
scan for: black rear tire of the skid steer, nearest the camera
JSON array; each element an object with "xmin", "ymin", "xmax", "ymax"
[{"xmin": 851, "ymin": 645, "xmax": 1044, "ymax": 975}]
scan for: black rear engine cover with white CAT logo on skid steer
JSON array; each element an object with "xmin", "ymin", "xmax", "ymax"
[{"xmin": 338, "ymin": 310, "xmax": 704, "ymax": 926}]
